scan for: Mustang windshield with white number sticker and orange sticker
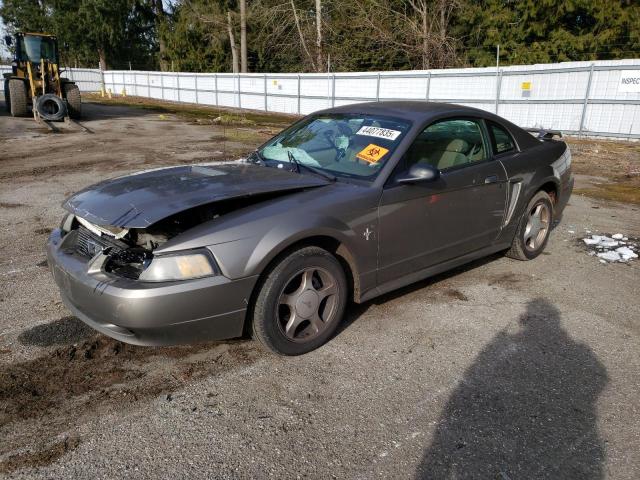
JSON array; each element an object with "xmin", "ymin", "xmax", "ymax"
[{"xmin": 258, "ymin": 114, "xmax": 410, "ymax": 180}]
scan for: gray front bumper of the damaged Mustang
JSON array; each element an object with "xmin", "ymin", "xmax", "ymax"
[{"xmin": 47, "ymin": 230, "xmax": 257, "ymax": 345}]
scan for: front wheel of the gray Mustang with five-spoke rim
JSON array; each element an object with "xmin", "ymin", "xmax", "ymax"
[{"xmin": 251, "ymin": 247, "xmax": 348, "ymax": 355}]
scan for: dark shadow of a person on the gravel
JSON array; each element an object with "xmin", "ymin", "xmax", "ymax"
[{"xmin": 416, "ymin": 299, "xmax": 607, "ymax": 480}]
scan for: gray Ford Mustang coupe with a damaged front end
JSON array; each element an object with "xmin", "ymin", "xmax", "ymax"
[{"xmin": 47, "ymin": 102, "xmax": 573, "ymax": 355}]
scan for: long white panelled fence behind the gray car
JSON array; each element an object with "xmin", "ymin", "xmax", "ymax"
[{"xmin": 5, "ymin": 59, "xmax": 640, "ymax": 139}]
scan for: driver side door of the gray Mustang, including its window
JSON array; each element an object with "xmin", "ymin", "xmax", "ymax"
[{"xmin": 378, "ymin": 118, "xmax": 506, "ymax": 284}]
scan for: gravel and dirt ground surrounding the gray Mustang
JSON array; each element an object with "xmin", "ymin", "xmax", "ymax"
[{"xmin": 0, "ymin": 100, "xmax": 640, "ymax": 479}]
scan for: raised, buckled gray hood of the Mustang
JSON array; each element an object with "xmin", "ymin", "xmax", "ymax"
[{"xmin": 62, "ymin": 163, "xmax": 329, "ymax": 228}]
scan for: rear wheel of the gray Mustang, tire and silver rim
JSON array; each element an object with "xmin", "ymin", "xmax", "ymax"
[{"xmin": 507, "ymin": 191, "xmax": 553, "ymax": 260}]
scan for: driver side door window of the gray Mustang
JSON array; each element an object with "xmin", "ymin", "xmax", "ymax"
[{"xmin": 405, "ymin": 119, "xmax": 487, "ymax": 170}]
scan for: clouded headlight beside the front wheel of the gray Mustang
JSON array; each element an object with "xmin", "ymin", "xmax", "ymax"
[{"xmin": 138, "ymin": 250, "xmax": 219, "ymax": 282}]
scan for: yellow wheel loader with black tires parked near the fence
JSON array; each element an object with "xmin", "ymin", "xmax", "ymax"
[{"xmin": 4, "ymin": 33, "xmax": 81, "ymax": 121}]
